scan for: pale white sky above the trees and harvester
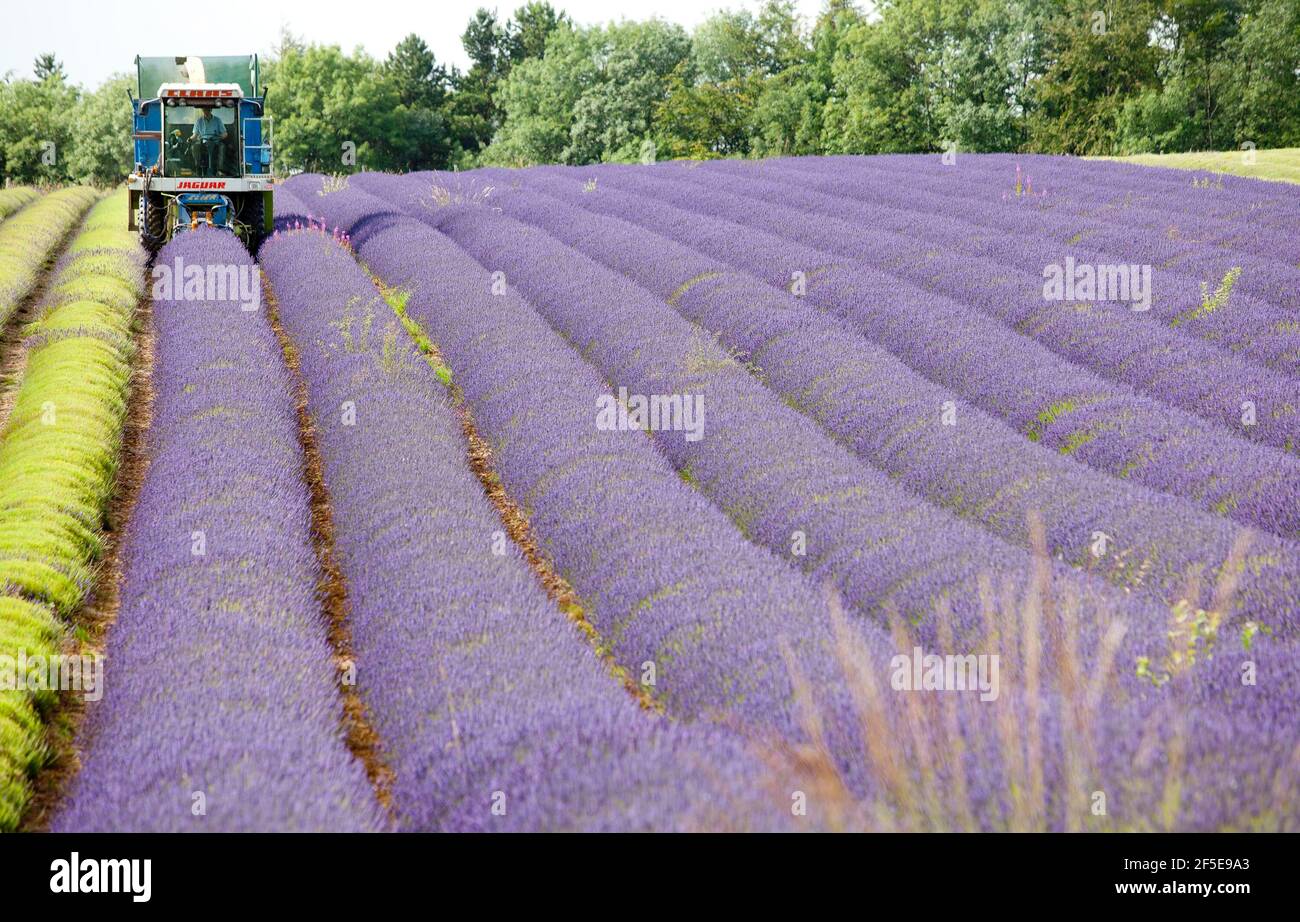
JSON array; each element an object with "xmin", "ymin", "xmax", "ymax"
[{"xmin": 0, "ymin": 0, "xmax": 822, "ymax": 88}]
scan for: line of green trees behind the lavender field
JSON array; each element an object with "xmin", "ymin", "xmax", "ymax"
[{"xmin": 0, "ymin": 0, "xmax": 1300, "ymax": 183}]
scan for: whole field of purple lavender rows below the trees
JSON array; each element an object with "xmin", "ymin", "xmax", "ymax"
[{"xmin": 0, "ymin": 153, "xmax": 1300, "ymax": 832}]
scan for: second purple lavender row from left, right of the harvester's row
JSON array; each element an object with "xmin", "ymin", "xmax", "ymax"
[{"xmin": 261, "ymin": 226, "xmax": 774, "ymax": 831}]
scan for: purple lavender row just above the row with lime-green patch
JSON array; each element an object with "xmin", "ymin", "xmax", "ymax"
[{"xmin": 657, "ymin": 170, "xmax": 1300, "ymax": 451}]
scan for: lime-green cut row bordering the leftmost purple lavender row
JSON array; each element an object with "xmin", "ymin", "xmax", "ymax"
[{"xmin": 0, "ymin": 191, "xmax": 146, "ymax": 831}]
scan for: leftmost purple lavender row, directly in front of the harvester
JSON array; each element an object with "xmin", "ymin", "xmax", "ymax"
[{"xmin": 53, "ymin": 228, "xmax": 382, "ymax": 831}]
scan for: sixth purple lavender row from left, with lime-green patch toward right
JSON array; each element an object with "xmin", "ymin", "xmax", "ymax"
[{"xmin": 499, "ymin": 168, "xmax": 1300, "ymax": 537}]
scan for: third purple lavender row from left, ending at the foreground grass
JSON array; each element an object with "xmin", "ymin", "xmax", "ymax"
[{"xmin": 279, "ymin": 176, "xmax": 888, "ymax": 769}]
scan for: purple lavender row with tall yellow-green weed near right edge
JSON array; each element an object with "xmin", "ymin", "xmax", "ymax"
[{"xmin": 743, "ymin": 157, "xmax": 1300, "ymax": 375}]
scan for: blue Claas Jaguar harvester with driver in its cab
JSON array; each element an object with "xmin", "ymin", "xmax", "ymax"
[{"xmin": 127, "ymin": 55, "xmax": 273, "ymax": 254}]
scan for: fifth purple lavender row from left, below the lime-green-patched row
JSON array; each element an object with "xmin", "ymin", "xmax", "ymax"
[{"xmin": 392, "ymin": 172, "xmax": 1300, "ymax": 624}]
